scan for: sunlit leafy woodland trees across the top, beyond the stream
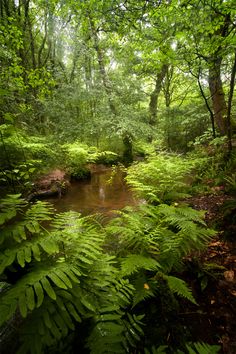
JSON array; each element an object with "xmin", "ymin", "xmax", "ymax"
[{"xmin": 0, "ymin": 0, "xmax": 236, "ymax": 152}]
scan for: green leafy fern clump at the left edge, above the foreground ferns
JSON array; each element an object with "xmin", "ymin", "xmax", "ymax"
[{"xmin": 0, "ymin": 123, "xmax": 61, "ymax": 191}]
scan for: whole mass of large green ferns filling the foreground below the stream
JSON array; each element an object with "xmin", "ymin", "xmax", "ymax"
[{"xmin": 0, "ymin": 195, "xmax": 219, "ymax": 354}]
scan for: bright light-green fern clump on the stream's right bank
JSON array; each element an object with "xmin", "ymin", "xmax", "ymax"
[{"xmin": 126, "ymin": 154, "xmax": 192, "ymax": 202}]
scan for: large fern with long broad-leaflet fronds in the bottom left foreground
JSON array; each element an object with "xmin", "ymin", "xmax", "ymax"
[{"xmin": 0, "ymin": 196, "xmax": 142, "ymax": 354}]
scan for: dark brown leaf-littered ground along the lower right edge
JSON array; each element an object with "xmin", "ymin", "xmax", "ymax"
[{"xmin": 184, "ymin": 194, "xmax": 236, "ymax": 354}]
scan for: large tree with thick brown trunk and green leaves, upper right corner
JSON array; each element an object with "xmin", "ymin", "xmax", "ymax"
[{"xmin": 176, "ymin": 1, "xmax": 236, "ymax": 141}]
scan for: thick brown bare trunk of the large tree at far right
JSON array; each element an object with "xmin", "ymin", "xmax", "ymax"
[{"xmin": 208, "ymin": 58, "xmax": 227, "ymax": 135}]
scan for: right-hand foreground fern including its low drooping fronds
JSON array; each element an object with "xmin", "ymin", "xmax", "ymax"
[{"xmin": 107, "ymin": 204, "xmax": 215, "ymax": 305}]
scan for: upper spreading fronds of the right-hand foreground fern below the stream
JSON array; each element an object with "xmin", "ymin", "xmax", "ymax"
[{"xmin": 107, "ymin": 204, "xmax": 215, "ymax": 272}]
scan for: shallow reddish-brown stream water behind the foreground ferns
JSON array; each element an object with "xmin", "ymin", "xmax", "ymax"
[{"xmin": 48, "ymin": 168, "xmax": 137, "ymax": 215}]
